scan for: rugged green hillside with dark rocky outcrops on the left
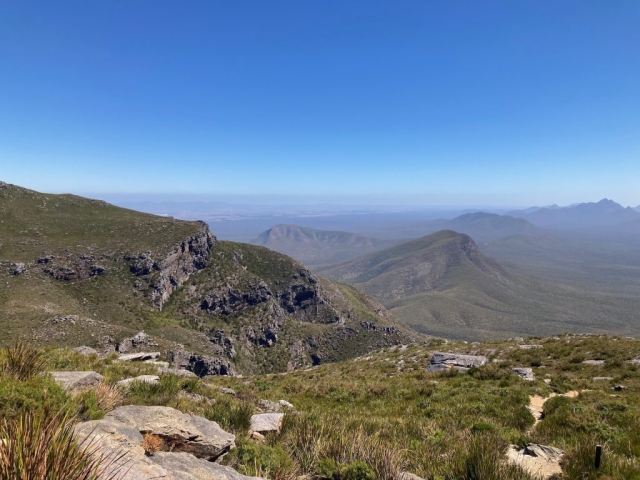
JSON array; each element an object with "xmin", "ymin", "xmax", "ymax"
[{"xmin": 0, "ymin": 184, "xmax": 413, "ymax": 372}]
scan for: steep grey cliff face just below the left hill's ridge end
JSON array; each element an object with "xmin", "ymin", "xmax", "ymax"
[{"xmin": 128, "ymin": 223, "xmax": 216, "ymax": 310}]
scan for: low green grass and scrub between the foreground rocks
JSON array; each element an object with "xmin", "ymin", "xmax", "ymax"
[{"xmin": 0, "ymin": 335, "xmax": 640, "ymax": 480}]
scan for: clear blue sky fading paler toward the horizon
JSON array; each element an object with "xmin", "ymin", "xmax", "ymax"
[{"xmin": 0, "ymin": 0, "xmax": 640, "ymax": 205}]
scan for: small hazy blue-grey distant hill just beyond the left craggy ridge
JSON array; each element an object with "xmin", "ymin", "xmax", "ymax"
[{"xmin": 251, "ymin": 225, "xmax": 397, "ymax": 266}]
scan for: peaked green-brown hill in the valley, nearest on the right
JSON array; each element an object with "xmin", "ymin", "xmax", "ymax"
[{"xmin": 321, "ymin": 231, "xmax": 640, "ymax": 340}]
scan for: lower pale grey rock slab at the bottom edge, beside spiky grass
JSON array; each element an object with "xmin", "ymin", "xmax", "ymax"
[{"xmin": 75, "ymin": 407, "xmax": 258, "ymax": 480}]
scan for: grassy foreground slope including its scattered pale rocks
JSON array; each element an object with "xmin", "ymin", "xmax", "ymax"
[{"xmin": 6, "ymin": 334, "xmax": 640, "ymax": 480}]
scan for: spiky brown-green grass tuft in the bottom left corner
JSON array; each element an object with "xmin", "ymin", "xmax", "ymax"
[{"xmin": 0, "ymin": 412, "xmax": 119, "ymax": 480}]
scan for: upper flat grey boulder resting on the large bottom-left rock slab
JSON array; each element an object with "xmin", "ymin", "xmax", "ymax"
[{"xmin": 103, "ymin": 405, "xmax": 235, "ymax": 460}]
